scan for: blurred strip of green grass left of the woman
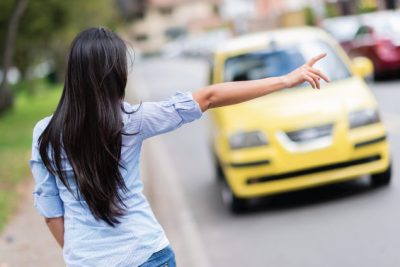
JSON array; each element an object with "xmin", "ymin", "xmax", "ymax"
[{"xmin": 0, "ymin": 82, "xmax": 61, "ymax": 231}]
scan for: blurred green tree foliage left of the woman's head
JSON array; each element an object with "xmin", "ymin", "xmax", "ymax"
[{"xmin": 0, "ymin": 0, "xmax": 122, "ymax": 112}]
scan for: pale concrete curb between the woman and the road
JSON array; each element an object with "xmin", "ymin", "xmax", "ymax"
[{"xmin": 142, "ymin": 137, "xmax": 211, "ymax": 267}]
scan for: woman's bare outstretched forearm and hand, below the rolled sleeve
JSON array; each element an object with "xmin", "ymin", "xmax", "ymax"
[{"xmin": 193, "ymin": 54, "xmax": 329, "ymax": 112}]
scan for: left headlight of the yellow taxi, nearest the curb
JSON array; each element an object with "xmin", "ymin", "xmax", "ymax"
[{"xmin": 229, "ymin": 131, "xmax": 267, "ymax": 149}]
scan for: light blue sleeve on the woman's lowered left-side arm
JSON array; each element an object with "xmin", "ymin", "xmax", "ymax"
[{"xmin": 29, "ymin": 120, "xmax": 64, "ymax": 218}]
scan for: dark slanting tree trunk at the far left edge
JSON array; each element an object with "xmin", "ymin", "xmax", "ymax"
[{"xmin": 0, "ymin": 0, "xmax": 28, "ymax": 113}]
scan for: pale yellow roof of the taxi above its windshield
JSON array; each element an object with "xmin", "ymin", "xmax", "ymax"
[{"xmin": 214, "ymin": 27, "xmax": 330, "ymax": 54}]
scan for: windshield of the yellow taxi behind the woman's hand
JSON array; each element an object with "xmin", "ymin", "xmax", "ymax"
[{"xmin": 224, "ymin": 41, "xmax": 351, "ymax": 86}]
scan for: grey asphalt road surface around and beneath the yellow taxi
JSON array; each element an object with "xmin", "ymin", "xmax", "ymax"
[{"xmin": 134, "ymin": 60, "xmax": 400, "ymax": 267}]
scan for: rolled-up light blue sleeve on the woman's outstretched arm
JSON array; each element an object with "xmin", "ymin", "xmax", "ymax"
[{"xmin": 140, "ymin": 91, "xmax": 203, "ymax": 138}]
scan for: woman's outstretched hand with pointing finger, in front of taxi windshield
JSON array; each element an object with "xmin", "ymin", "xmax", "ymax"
[{"xmin": 284, "ymin": 54, "xmax": 330, "ymax": 89}]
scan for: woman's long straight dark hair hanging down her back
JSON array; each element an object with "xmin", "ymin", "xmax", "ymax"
[{"xmin": 39, "ymin": 28, "xmax": 134, "ymax": 226}]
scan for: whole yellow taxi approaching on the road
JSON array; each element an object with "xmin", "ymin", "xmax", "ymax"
[{"xmin": 211, "ymin": 28, "xmax": 391, "ymax": 211}]
